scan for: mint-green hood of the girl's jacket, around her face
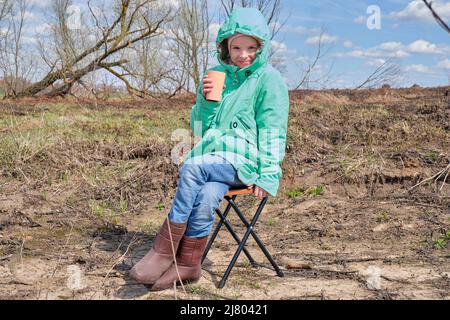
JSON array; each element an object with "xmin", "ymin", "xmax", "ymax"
[{"xmin": 216, "ymin": 8, "xmax": 271, "ymax": 69}]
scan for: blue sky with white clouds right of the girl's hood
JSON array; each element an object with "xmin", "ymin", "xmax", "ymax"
[{"xmin": 209, "ymin": 0, "xmax": 450, "ymax": 88}]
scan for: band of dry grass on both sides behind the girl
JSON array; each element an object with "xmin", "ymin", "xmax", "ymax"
[{"xmin": 0, "ymin": 88, "xmax": 450, "ymax": 205}]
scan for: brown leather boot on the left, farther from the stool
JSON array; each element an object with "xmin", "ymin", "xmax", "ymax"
[{"xmin": 129, "ymin": 219, "xmax": 187, "ymax": 284}]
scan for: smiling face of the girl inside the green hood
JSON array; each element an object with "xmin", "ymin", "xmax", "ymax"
[{"xmin": 230, "ymin": 36, "xmax": 259, "ymax": 69}]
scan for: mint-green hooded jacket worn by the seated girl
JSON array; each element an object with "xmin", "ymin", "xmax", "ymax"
[{"xmin": 186, "ymin": 8, "xmax": 289, "ymax": 196}]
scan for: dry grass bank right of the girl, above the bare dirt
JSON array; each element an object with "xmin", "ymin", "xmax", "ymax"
[{"xmin": 288, "ymin": 89, "xmax": 450, "ymax": 188}]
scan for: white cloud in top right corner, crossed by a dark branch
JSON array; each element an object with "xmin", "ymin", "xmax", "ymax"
[{"xmin": 390, "ymin": 0, "xmax": 450, "ymax": 21}]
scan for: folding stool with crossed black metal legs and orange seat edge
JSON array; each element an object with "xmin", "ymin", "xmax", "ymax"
[{"xmin": 202, "ymin": 186, "xmax": 284, "ymax": 288}]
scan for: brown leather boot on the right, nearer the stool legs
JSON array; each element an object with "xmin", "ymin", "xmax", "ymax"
[{"xmin": 151, "ymin": 236, "xmax": 208, "ymax": 291}]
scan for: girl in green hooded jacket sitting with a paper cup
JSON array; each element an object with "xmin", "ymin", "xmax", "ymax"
[{"xmin": 130, "ymin": 8, "xmax": 289, "ymax": 290}]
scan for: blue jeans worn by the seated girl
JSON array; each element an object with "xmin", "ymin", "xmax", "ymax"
[{"xmin": 169, "ymin": 154, "xmax": 246, "ymax": 237}]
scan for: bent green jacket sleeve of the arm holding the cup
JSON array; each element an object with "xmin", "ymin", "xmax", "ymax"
[{"xmin": 189, "ymin": 79, "xmax": 220, "ymax": 137}]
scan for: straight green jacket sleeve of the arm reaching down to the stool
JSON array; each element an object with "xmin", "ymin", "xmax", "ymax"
[{"xmin": 255, "ymin": 76, "xmax": 289, "ymax": 196}]
